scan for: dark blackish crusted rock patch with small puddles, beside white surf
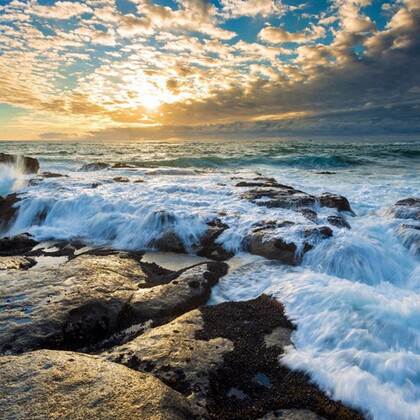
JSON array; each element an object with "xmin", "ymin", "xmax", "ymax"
[{"xmin": 196, "ymin": 295, "xmax": 363, "ymax": 420}]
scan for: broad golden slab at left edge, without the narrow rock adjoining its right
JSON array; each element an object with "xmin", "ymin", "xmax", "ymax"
[{"xmin": 0, "ymin": 255, "xmax": 146, "ymax": 353}]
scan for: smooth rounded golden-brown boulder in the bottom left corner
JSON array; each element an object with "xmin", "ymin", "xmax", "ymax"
[{"xmin": 0, "ymin": 350, "xmax": 196, "ymax": 420}]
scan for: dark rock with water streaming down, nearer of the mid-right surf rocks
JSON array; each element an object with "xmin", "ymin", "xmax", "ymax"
[{"xmin": 243, "ymin": 221, "xmax": 333, "ymax": 265}]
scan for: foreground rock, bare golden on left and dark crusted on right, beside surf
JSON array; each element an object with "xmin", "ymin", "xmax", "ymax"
[{"xmin": 101, "ymin": 295, "xmax": 362, "ymax": 420}]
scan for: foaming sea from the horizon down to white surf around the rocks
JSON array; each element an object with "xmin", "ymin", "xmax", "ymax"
[{"xmin": 0, "ymin": 140, "xmax": 420, "ymax": 420}]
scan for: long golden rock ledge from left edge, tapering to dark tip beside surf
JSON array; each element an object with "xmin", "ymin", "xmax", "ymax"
[{"xmin": 0, "ymin": 254, "xmax": 227, "ymax": 353}]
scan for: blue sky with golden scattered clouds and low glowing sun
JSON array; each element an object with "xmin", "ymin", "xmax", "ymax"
[{"xmin": 0, "ymin": 0, "xmax": 420, "ymax": 140}]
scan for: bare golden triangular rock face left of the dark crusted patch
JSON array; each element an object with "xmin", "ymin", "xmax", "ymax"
[{"xmin": 103, "ymin": 309, "xmax": 233, "ymax": 406}]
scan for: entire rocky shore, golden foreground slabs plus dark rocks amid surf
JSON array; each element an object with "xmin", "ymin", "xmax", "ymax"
[{"xmin": 0, "ymin": 155, "xmax": 420, "ymax": 420}]
